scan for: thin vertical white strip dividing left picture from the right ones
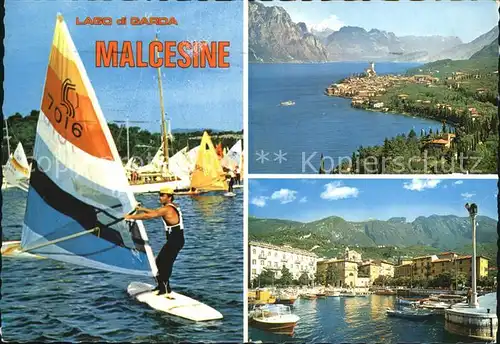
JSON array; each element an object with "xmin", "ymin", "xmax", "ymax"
[{"xmin": 243, "ymin": 0, "xmax": 251, "ymax": 343}]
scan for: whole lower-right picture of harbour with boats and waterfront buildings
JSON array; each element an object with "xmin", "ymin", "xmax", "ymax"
[{"xmin": 246, "ymin": 178, "xmax": 498, "ymax": 344}]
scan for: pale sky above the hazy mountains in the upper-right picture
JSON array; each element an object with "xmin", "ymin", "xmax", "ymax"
[{"xmin": 276, "ymin": 0, "xmax": 498, "ymax": 43}]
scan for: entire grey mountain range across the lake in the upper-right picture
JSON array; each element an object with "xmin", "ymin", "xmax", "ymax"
[{"xmin": 248, "ymin": 1, "xmax": 498, "ymax": 62}]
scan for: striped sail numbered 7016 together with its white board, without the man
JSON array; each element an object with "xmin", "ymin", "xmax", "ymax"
[{"xmin": 16, "ymin": 14, "xmax": 222, "ymax": 321}]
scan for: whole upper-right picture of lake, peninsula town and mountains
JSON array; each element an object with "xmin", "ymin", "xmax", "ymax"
[{"xmin": 248, "ymin": 1, "xmax": 498, "ymax": 174}]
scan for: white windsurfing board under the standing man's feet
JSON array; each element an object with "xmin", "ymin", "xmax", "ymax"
[{"xmin": 127, "ymin": 282, "xmax": 222, "ymax": 321}]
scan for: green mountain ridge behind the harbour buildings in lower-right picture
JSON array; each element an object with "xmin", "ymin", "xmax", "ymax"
[{"xmin": 248, "ymin": 215, "xmax": 497, "ymax": 252}]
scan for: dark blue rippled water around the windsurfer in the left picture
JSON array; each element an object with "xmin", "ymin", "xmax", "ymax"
[{"xmin": 0, "ymin": 189, "xmax": 243, "ymax": 342}]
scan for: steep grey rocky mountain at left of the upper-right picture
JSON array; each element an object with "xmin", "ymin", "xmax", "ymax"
[{"xmin": 248, "ymin": 1, "xmax": 328, "ymax": 62}]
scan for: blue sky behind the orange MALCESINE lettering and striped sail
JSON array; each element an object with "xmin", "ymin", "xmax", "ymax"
[{"xmin": 3, "ymin": 0, "xmax": 243, "ymax": 132}]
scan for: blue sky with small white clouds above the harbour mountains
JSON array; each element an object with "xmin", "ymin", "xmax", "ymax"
[{"xmin": 248, "ymin": 178, "xmax": 498, "ymax": 222}]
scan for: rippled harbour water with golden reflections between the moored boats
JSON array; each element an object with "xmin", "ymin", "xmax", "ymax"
[{"xmin": 249, "ymin": 295, "xmax": 490, "ymax": 344}]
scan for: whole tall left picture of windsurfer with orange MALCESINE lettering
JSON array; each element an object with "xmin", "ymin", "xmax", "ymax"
[{"xmin": 0, "ymin": 1, "xmax": 245, "ymax": 343}]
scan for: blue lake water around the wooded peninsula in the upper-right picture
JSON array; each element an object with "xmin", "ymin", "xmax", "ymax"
[{"xmin": 248, "ymin": 62, "xmax": 441, "ymax": 173}]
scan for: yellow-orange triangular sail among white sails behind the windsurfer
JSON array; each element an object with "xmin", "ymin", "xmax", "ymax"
[{"xmin": 191, "ymin": 132, "xmax": 228, "ymax": 191}]
